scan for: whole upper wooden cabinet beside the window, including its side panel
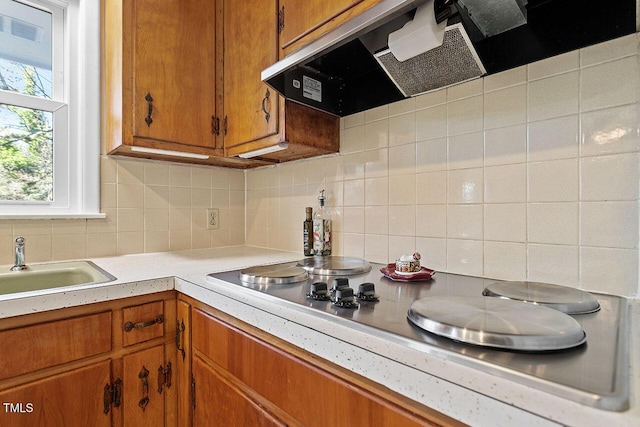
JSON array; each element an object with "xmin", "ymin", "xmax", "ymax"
[{"xmin": 102, "ymin": 0, "xmax": 256, "ymax": 167}]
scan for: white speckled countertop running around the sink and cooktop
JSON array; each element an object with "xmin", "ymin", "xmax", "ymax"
[{"xmin": 0, "ymin": 246, "xmax": 640, "ymax": 427}]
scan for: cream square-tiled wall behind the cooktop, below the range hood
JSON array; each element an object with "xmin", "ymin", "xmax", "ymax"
[{"xmin": 246, "ymin": 34, "xmax": 640, "ymax": 296}]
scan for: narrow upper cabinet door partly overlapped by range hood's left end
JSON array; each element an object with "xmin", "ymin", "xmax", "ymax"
[{"xmin": 224, "ymin": 0, "xmax": 279, "ymax": 148}]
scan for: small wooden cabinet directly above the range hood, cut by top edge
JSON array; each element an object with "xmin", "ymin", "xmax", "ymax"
[{"xmin": 279, "ymin": 0, "xmax": 381, "ymax": 55}]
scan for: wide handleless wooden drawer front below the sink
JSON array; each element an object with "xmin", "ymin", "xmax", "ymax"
[{"xmin": 0, "ymin": 311, "xmax": 111, "ymax": 380}]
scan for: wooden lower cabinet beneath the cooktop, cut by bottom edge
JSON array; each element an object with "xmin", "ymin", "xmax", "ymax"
[{"xmin": 180, "ymin": 297, "xmax": 461, "ymax": 427}]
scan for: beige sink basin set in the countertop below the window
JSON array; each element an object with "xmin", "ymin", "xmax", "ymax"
[{"xmin": 0, "ymin": 261, "xmax": 116, "ymax": 295}]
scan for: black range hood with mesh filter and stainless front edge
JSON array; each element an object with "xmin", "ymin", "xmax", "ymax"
[{"xmin": 262, "ymin": 0, "xmax": 637, "ymax": 117}]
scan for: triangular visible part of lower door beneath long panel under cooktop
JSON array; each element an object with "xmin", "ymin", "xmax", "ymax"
[{"xmin": 192, "ymin": 357, "xmax": 286, "ymax": 427}]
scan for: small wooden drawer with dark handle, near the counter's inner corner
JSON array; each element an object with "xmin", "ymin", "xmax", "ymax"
[{"xmin": 122, "ymin": 301, "xmax": 164, "ymax": 347}]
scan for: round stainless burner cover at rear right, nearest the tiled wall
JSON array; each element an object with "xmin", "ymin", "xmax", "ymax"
[{"xmin": 482, "ymin": 282, "xmax": 600, "ymax": 314}]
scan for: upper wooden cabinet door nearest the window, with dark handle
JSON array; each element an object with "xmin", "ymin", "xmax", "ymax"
[{"xmin": 131, "ymin": 0, "xmax": 216, "ymax": 148}]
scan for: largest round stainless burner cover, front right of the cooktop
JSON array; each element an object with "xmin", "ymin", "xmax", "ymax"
[{"xmin": 407, "ymin": 296, "xmax": 587, "ymax": 351}]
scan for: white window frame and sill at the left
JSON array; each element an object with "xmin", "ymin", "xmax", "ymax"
[{"xmin": 0, "ymin": 0, "xmax": 106, "ymax": 219}]
